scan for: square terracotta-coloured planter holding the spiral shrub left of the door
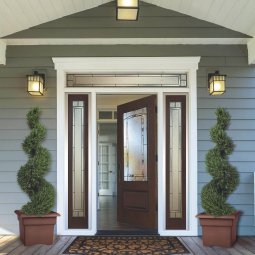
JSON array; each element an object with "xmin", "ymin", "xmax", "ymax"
[{"xmin": 15, "ymin": 210, "xmax": 60, "ymax": 245}]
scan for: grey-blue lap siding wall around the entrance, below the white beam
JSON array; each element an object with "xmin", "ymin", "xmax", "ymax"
[{"xmin": 0, "ymin": 45, "xmax": 255, "ymax": 235}]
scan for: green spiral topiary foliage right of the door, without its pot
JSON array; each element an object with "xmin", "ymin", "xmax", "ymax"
[{"xmin": 201, "ymin": 108, "xmax": 239, "ymax": 216}]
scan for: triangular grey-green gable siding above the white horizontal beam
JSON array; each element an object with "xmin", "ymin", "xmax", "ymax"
[{"xmin": 7, "ymin": 1, "xmax": 248, "ymax": 38}]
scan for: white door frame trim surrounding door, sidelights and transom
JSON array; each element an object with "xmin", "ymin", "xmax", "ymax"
[{"xmin": 53, "ymin": 57, "xmax": 200, "ymax": 236}]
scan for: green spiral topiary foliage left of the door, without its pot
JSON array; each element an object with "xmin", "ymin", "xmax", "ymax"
[{"xmin": 18, "ymin": 108, "xmax": 55, "ymax": 215}]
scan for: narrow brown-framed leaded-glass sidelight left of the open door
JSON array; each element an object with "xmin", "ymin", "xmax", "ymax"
[{"xmin": 68, "ymin": 95, "xmax": 88, "ymax": 228}]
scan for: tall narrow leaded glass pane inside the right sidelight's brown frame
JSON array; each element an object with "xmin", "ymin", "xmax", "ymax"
[{"xmin": 168, "ymin": 102, "xmax": 182, "ymax": 218}]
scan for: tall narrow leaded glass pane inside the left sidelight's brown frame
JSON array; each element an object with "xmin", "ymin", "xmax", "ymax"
[{"xmin": 72, "ymin": 101, "xmax": 85, "ymax": 217}]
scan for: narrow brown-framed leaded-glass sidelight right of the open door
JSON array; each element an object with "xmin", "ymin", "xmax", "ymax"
[{"xmin": 166, "ymin": 96, "xmax": 186, "ymax": 229}]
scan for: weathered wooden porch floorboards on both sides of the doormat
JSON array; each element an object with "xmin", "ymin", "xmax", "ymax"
[{"xmin": 0, "ymin": 236, "xmax": 255, "ymax": 255}]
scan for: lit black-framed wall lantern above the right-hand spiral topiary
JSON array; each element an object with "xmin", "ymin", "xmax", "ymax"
[{"xmin": 208, "ymin": 71, "xmax": 227, "ymax": 96}]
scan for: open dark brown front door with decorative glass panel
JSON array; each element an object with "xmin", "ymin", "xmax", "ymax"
[{"xmin": 117, "ymin": 96, "xmax": 157, "ymax": 229}]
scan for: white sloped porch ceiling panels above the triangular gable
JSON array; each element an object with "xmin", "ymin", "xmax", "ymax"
[{"xmin": 0, "ymin": 0, "xmax": 255, "ymax": 37}]
